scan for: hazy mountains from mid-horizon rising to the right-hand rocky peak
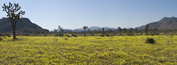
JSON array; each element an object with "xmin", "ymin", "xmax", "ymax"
[{"xmin": 55, "ymin": 17, "xmax": 177, "ymax": 32}]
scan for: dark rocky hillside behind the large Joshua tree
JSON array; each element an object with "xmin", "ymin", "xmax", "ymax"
[{"xmin": 0, "ymin": 18, "xmax": 49, "ymax": 33}]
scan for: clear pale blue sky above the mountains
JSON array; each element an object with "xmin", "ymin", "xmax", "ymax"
[{"xmin": 0, "ymin": 0, "xmax": 177, "ymax": 30}]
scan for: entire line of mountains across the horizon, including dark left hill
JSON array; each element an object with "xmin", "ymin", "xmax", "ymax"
[{"xmin": 0, "ymin": 17, "xmax": 177, "ymax": 33}]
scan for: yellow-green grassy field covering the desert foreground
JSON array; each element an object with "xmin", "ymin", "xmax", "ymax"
[{"xmin": 0, "ymin": 35, "xmax": 177, "ymax": 65}]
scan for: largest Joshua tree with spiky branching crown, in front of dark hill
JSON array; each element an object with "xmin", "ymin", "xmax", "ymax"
[{"xmin": 2, "ymin": 2, "xmax": 25, "ymax": 39}]
